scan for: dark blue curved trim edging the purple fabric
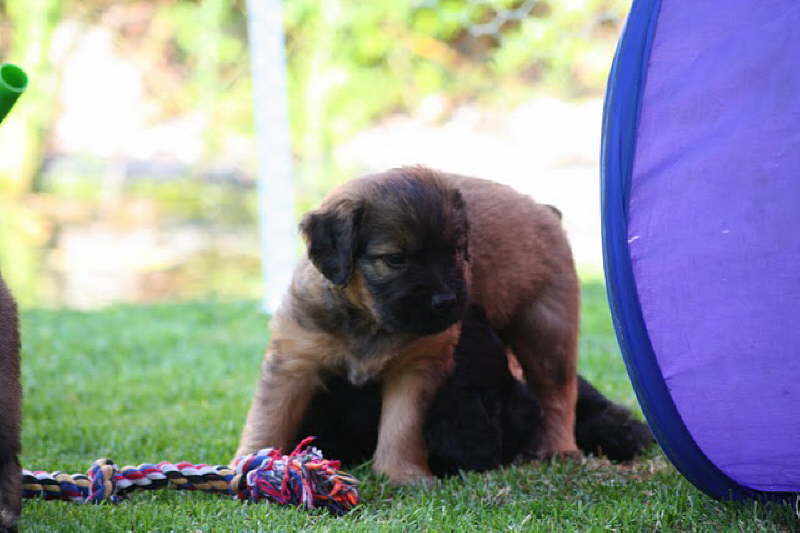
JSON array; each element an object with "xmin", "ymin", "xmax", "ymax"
[{"xmin": 601, "ymin": 0, "xmax": 794, "ymax": 500}]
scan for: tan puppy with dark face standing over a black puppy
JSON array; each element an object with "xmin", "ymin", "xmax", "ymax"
[{"xmin": 237, "ymin": 167, "xmax": 579, "ymax": 483}]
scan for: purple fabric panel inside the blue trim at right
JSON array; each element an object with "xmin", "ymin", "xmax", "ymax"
[{"xmin": 628, "ymin": 0, "xmax": 800, "ymax": 491}]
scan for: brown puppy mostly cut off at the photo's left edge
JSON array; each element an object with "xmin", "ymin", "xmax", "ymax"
[{"xmin": 0, "ymin": 277, "xmax": 22, "ymax": 531}]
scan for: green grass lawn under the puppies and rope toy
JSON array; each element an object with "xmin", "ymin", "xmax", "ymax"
[{"xmin": 21, "ymin": 283, "xmax": 800, "ymax": 532}]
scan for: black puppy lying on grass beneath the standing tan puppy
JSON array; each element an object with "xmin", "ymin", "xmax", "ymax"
[{"xmin": 297, "ymin": 308, "xmax": 653, "ymax": 476}]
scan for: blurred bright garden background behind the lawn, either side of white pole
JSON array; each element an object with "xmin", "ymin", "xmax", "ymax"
[{"xmin": 0, "ymin": 0, "xmax": 629, "ymax": 307}]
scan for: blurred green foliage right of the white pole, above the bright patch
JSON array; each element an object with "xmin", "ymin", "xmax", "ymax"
[{"xmin": 285, "ymin": 0, "xmax": 628, "ymax": 204}]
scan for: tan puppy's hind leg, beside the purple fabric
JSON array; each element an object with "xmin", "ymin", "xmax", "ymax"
[{"xmin": 501, "ymin": 275, "xmax": 580, "ymax": 457}]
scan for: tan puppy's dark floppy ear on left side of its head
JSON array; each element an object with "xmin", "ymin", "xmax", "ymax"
[{"xmin": 300, "ymin": 202, "xmax": 364, "ymax": 285}]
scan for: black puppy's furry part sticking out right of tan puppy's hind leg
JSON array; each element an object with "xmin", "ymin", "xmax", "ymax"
[{"xmin": 575, "ymin": 376, "xmax": 653, "ymax": 461}]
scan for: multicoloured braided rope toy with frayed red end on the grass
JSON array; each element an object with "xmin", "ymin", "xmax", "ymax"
[{"xmin": 22, "ymin": 437, "xmax": 359, "ymax": 515}]
